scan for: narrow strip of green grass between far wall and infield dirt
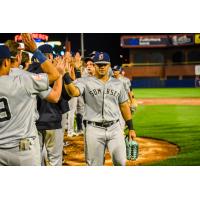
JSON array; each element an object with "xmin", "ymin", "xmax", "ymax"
[{"xmin": 133, "ymin": 88, "xmax": 200, "ymax": 99}]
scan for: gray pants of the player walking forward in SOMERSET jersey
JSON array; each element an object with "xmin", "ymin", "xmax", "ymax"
[{"xmin": 85, "ymin": 122, "xmax": 126, "ymax": 166}]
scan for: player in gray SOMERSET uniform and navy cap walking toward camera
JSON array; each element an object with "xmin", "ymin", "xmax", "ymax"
[{"xmin": 64, "ymin": 53, "xmax": 136, "ymax": 166}]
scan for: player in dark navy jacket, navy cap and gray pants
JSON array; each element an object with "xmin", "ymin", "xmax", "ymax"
[{"xmin": 29, "ymin": 44, "xmax": 68, "ymax": 166}]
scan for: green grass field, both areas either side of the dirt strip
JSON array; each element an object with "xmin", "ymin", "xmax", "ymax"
[{"xmin": 134, "ymin": 88, "xmax": 200, "ymax": 166}]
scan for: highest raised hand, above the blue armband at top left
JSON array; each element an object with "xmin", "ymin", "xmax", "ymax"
[{"xmin": 21, "ymin": 33, "xmax": 37, "ymax": 53}]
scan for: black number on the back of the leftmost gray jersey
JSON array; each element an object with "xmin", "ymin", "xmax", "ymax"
[{"xmin": 0, "ymin": 97, "xmax": 11, "ymax": 122}]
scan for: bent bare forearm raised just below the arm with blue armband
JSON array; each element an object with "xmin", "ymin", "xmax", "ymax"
[{"xmin": 46, "ymin": 76, "xmax": 62, "ymax": 103}]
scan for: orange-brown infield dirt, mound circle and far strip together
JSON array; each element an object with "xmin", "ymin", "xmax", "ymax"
[{"xmin": 63, "ymin": 98, "xmax": 200, "ymax": 166}]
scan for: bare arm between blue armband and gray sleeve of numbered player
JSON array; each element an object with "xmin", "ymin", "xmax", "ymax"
[{"xmin": 41, "ymin": 60, "xmax": 60, "ymax": 84}]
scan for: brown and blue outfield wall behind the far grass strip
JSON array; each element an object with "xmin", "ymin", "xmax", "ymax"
[{"xmin": 123, "ymin": 65, "xmax": 195, "ymax": 88}]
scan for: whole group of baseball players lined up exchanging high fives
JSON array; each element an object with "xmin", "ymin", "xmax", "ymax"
[{"xmin": 0, "ymin": 34, "xmax": 137, "ymax": 166}]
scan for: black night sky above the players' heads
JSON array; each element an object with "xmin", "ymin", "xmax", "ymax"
[{"xmin": 0, "ymin": 33, "xmax": 128, "ymax": 65}]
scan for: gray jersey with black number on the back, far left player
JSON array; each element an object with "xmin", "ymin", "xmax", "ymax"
[{"xmin": 0, "ymin": 68, "xmax": 50, "ymax": 148}]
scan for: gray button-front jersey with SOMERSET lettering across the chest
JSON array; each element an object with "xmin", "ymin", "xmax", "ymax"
[{"xmin": 75, "ymin": 77, "xmax": 128, "ymax": 122}]
